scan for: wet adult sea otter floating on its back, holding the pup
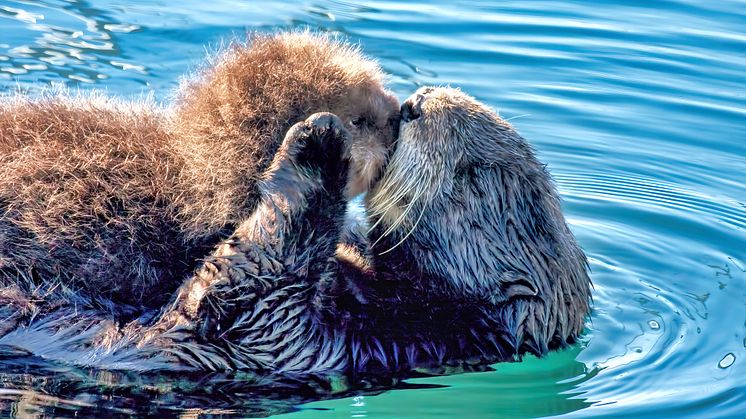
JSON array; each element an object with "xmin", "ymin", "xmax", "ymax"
[{"xmin": 0, "ymin": 88, "xmax": 590, "ymax": 374}]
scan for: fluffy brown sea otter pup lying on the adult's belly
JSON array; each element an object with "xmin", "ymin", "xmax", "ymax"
[{"xmin": 0, "ymin": 32, "xmax": 399, "ymax": 318}]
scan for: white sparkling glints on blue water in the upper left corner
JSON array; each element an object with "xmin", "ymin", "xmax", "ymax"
[{"xmin": 0, "ymin": 1, "xmax": 148, "ymax": 89}]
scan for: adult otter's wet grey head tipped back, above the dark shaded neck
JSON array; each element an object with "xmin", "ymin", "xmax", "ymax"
[{"xmin": 366, "ymin": 87, "xmax": 589, "ymax": 342}]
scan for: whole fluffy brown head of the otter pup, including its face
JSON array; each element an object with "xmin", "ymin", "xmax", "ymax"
[{"xmin": 171, "ymin": 31, "xmax": 399, "ymax": 234}]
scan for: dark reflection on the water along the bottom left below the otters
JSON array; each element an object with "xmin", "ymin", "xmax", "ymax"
[{"xmin": 0, "ymin": 352, "xmax": 460, "ymax": 417}]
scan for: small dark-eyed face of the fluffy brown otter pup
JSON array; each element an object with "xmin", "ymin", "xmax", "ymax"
[{"xmin": 332, "ymin": 86, "xmax": 399, "ymax": 198}]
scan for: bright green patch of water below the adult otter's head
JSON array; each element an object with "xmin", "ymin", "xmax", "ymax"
[{"xmin": 293, "ymin": 345, "xmax": 599, "ymax": 418}]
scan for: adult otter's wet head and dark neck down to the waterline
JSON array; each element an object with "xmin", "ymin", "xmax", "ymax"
[{"xmin": 367, "ymin": 88, "xmax": 590, "ymax": 358}]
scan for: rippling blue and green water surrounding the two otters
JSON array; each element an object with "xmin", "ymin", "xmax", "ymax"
[{"xmin": 0, "ymin": 0, "xmax": 746, "ymax": 418}]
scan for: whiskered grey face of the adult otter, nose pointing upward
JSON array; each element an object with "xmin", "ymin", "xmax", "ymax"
[{"xmin": 368, "ymin": 87, "xmax": 538, "ymax": 240}]
